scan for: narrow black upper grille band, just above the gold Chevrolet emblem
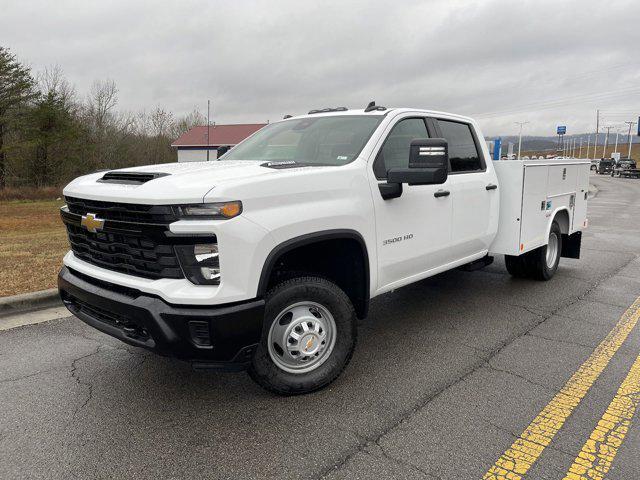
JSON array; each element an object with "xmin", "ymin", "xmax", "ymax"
[{"xmin": 65, "ymin": 197, "xmax": 178, "ymax": 223}]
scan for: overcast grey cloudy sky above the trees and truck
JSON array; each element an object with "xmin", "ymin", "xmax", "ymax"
[{"xmin": 0, "ymin": 0, "xmax": 640, "ymax": 135}]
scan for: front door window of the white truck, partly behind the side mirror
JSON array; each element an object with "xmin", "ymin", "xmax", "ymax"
[{"xmin": 373, "ymin": 118, "xmax": 429, "ymax": 179}]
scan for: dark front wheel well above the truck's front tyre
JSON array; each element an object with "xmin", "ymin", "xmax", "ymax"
[{"xmin": 258, "ymin": 233, "xmax": 369, "ymax": 318}]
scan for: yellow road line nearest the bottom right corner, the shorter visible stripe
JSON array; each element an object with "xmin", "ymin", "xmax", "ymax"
[{"xmin": 564, "ymin": 348, "xmax": 640, "ymax": 480}]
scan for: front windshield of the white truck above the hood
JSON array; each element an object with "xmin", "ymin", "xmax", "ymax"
[{"xmin": 221, "ymin": 115, "xmax": 383, "ymax": 165}]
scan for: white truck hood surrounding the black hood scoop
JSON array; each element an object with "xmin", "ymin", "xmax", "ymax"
[{"xmin": 64, "ymin": 160, "xmax": 280, "ymax": 205}]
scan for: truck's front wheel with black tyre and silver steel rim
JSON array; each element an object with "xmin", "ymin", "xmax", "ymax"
[{"xmin": 249, "ymin": 277, "xmax": 357, "ymax": 395}]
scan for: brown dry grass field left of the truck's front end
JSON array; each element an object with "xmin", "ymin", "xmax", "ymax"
[{"xmin": 0, "ymin": 200, "xmax": 69, "ymax": 296}]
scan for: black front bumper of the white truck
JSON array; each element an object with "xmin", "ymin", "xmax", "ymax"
[{"xmin": 58, "ymin": 267, "xmax": 264, "ymax": 370}]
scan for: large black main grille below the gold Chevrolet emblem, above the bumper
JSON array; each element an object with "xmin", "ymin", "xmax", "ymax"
[{"xmin": 67, "ymin": 223, "xmax": 184, "ymax": 279}]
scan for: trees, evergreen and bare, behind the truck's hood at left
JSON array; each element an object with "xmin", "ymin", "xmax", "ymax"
[{"xmin": 0, "ymin": 46, "xmax": 206, "ymax": 189}]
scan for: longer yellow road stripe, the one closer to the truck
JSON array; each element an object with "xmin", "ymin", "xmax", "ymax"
[{"xmin": 483, "ymin": 297, "xmax": 640, "ymax": 480}]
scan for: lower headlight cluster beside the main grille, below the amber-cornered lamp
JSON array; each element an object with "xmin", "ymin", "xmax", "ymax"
[{"xmin": 175, "ymin": 243, "xmax": 220, "ymax": 285}]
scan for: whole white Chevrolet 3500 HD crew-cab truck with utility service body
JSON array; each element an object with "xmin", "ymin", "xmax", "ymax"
[{"xmin": 59, "ymin": 102, "xmax": 589, "ymax": 394}]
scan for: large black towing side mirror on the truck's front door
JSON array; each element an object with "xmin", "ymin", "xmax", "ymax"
[{"xmin": 380, "ymin": 138, "xmax": 449, "ymax": 200}]
